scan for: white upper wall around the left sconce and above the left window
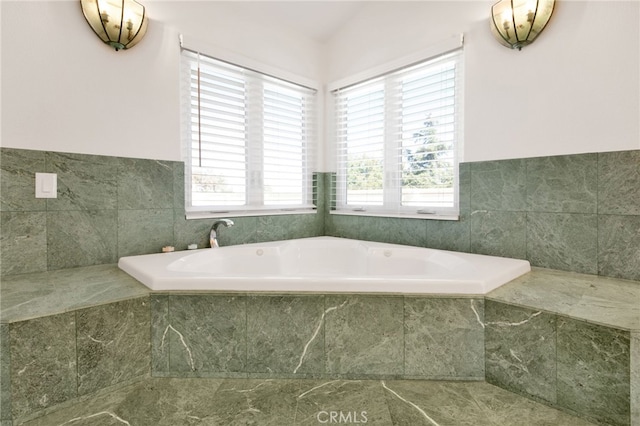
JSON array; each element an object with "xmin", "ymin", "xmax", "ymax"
[{"xmin": 0, "ymin": 0, "xmax": 321, "ymax": 160}]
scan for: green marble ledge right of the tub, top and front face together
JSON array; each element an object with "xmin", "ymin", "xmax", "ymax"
[{"xmin": 485, "ymin": 268, "xmax": 640, "ymax": 426}]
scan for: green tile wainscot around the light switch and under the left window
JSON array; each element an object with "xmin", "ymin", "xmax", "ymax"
[{"xmin": 0, "ymin": 148, "xmax": 324, "ymax": 276}]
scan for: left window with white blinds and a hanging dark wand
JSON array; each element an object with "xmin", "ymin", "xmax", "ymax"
[{"xmin": 182, "ymin": 49, "xmax": 315, "ymax": 218}]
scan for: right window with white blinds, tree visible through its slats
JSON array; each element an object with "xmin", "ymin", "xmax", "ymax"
[{"xmin": 334, "ymin": 45, "xmax": 462, "ymax": 219}]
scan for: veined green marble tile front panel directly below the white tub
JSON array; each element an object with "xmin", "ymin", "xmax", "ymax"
[{"xmin": 151, "ymin": 294, "xmax": 484, "ymax": 380}]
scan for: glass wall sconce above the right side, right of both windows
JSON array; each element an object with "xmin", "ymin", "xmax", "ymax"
[{"xmin": 491, "ymin": 0, "xmax": 555, "ymax": 50}]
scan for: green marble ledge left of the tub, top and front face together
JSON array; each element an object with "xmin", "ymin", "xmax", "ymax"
[{"xmin": 0, "ymin": 265, "xmax": 150, "ymax": 422}]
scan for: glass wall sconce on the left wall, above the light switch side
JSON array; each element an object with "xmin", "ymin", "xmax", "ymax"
[{"xmin": 80, "ymin": 0, "xmax": 148, "ymax": 51}]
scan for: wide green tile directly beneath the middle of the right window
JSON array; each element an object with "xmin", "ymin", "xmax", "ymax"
[{"xmin": 358, "ymin": 217, "xmax": 430, "ymax": 247}]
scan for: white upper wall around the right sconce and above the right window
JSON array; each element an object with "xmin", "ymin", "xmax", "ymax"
[{"xmin": 327, "ymin": 0, "xmax": 640, "ymax": 161}]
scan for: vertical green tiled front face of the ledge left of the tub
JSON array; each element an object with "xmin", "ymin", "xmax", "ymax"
[{"xmin": 5, "ymin": 296, "xmax": 150, "ymax": 421}]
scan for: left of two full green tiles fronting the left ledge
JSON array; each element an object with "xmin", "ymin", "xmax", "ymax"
[{"xmin": 9, "ymin": 313, "xmax": 77, "ymax": 419}]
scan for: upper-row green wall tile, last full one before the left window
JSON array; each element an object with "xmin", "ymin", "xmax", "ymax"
[{"xmin": 118, "ymin": 158, "xmax": 175, "ymax": 210}]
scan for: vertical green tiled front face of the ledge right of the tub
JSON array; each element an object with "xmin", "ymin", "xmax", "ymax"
[{"xmin": 485, "ymin": 300, "xmax": 638, "ymax": 425}]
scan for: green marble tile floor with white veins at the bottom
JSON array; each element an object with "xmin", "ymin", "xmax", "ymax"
[{"xmin": 18, "ymin": 378, "xmax": 592, "ymax": 426}]
